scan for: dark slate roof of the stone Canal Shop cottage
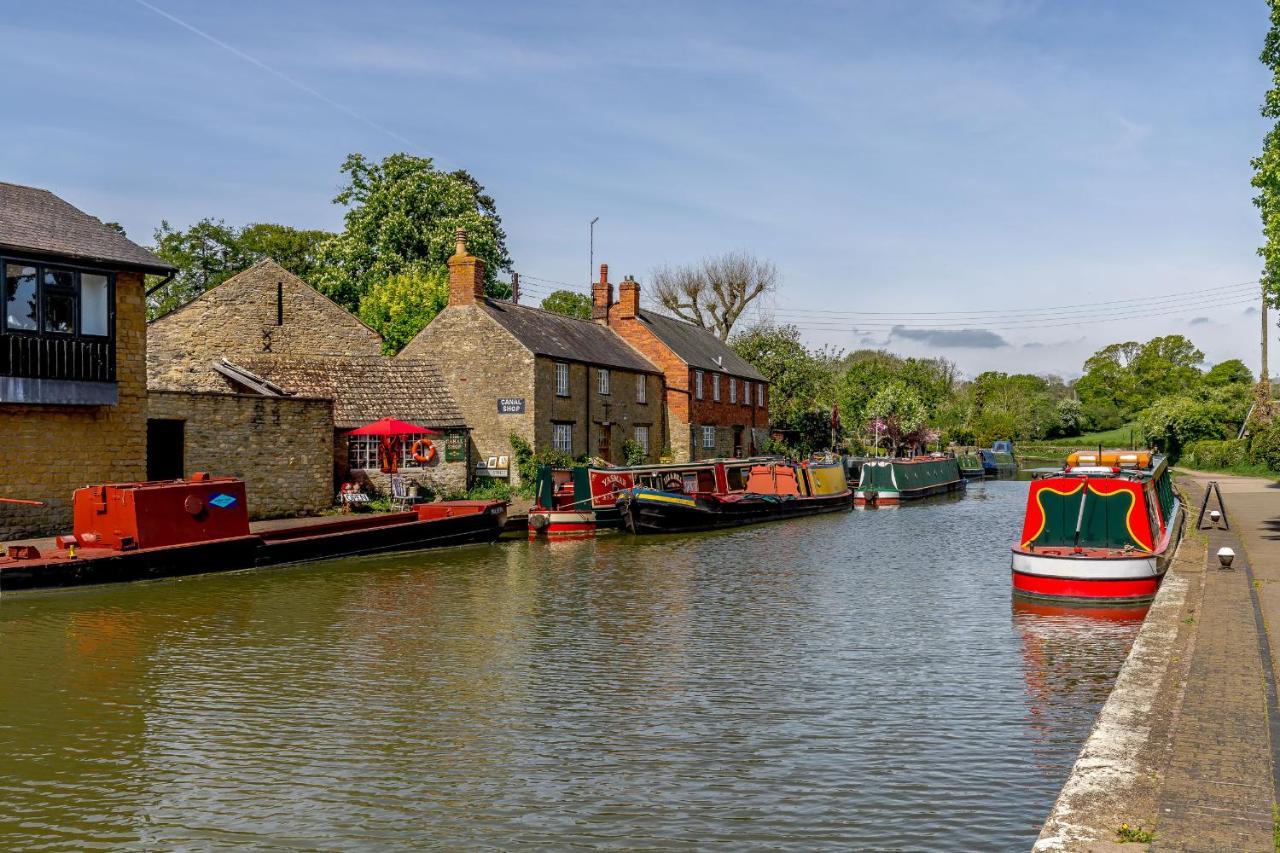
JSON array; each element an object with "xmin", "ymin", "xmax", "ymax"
[{"xmin": 480, "ymin": 300, "xmax": 660, "ymax": 373}]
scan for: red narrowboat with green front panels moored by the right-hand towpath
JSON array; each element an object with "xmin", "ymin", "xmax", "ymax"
[{"xmin": 1011, "ymin": 451, "xmax": 1184, "ymax": 605}]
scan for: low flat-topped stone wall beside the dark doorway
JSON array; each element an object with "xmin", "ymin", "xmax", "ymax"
[{"xmin": 147, "ymin": 391, "xmax": 335, "ymax": 519}]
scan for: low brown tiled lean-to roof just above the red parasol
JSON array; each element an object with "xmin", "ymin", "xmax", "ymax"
[{"xmin": 214, "ymin": 356, "xmax": 466, "ymax": 429}]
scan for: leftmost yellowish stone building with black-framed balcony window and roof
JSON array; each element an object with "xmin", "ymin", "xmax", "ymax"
[{"xmin": 0, "ymin": 183, "xmax": 175, "ymax": 538}]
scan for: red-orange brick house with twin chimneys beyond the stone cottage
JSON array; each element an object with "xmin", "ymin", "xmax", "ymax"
[{"xmin": 591, "ymin": 264, "xmax": 769, "ymax": 462}]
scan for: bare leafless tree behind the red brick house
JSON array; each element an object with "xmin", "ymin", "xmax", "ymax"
[{"xmin": 652, "ymin": 252, "xmax": 778, "ymax": 341}]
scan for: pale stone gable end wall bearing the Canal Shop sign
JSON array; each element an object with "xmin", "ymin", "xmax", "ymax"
[{"xmin": 401, "ymin": 304, "xmax": 536, "ymax": 485}]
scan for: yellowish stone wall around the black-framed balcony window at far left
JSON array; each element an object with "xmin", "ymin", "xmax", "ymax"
[{"xmin": 0, "ymin": 273, "xmax": 147, "ymax": 539}]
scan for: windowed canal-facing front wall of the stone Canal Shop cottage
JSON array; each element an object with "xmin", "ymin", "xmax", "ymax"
[{"xmin": 534, "ymin": 357, "xmax": 667, "ymax": 465}]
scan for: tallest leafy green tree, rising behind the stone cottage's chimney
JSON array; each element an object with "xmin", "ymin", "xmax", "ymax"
[{"xmin": 320, "ymin": 154, "xmax": 511, "ymax": 310}]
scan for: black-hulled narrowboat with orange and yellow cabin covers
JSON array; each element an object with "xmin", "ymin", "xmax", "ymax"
[{"xmin": 618, "ymin": 459, "xmax": 850, "ymax": 533}]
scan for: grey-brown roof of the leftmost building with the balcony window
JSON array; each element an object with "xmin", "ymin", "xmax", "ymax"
[{"xmin": 0, "ymin": 182, "xmax": 174, "ymax": 274}]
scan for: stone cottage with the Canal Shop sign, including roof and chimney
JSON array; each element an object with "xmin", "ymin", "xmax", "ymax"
[{"xmin": 399, "ymin": 233, "xmax": 667, "ymax": 479}]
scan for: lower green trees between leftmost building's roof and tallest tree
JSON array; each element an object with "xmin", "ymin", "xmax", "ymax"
[{"xmin": 147, "ymin": 218, "xmax": 333, "ymax": 318}]
